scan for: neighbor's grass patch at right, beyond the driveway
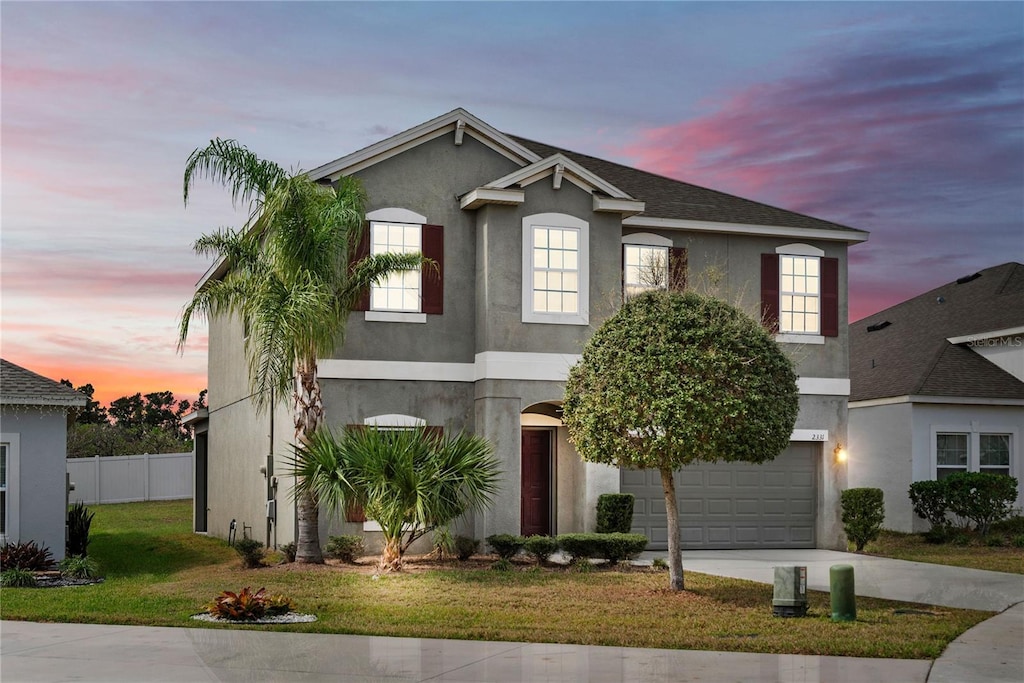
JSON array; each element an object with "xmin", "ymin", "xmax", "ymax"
[{"xmin": 864, "ymin": 530, "xmax": 1024, "ymax": 573}]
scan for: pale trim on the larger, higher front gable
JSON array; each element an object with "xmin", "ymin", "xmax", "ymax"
[{"xmin": 308, "ymin": 109, "xmax": 540, "ymax": 180}]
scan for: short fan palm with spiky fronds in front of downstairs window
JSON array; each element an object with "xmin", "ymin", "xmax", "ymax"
[{"xmin": 293, "ymin": 427, "xmax": 501, "ymax": 571}]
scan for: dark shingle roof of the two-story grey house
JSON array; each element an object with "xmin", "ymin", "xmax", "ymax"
[{"xmin": 509, "ymin": 135, "xmax": 862, "ymax": 233}]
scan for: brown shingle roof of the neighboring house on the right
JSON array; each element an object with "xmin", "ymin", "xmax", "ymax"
[{"xmin": 850, "ymin": 262, "xmax": 1024, "ymax": 400}]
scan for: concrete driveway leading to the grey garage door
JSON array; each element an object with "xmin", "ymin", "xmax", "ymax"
[{"xmin": 640, "ymin": 550, "xmax": 1024, "ymax": 611}]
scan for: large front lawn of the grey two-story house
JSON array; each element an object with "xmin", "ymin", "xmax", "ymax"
[{"xmin": 0, "ymin": 501, "xmax": 991, "ymax": 658}]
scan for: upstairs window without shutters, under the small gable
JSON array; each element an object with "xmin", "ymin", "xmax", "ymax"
[{"xmin": 522, "ymin": 213, "xmax": 590, "ymax": 325}]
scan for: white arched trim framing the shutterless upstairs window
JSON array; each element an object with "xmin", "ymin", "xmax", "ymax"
[{"xmin": 522, "ymin": 213, "xmax": 590, "ymax": 325}]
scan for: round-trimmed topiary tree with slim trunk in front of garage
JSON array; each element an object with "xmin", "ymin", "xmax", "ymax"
[{"xmin": 562, "ymin": 291, "xmax": 799, "ymax": 590}]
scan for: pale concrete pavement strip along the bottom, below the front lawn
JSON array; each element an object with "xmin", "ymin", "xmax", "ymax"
[{"xmin": 0, "ymin": 622, "xmax": 932, "ymax": 683}]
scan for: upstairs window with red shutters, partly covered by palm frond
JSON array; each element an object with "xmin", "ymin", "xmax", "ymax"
[{"xmin": 352, "ymin": 208, "xmax": 444, "ymax": 323}]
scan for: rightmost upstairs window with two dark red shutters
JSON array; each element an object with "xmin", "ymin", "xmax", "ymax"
[{"xmin": 761, "ymin": 244, "xmax": 839, "ymax": 343}]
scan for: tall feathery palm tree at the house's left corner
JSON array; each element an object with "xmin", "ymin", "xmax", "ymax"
[{"xmin": 178, "ymin": 138, "xmax": 424, "ymax": 563}]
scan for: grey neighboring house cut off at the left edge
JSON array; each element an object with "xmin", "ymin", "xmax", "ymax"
[{"xmin": 0, "ymin": 359, "xmax": 87, "ymax": 560}]
